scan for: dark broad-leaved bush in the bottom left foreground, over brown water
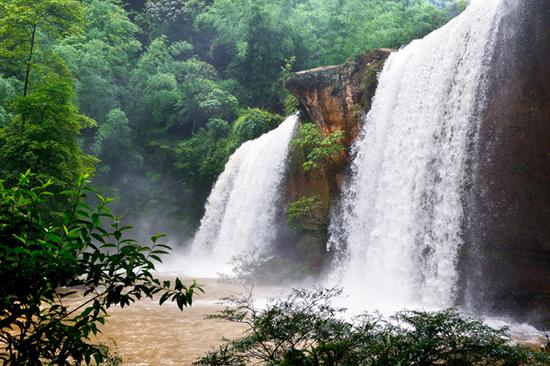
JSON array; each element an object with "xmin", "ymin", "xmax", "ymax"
[{"xmin": 0, "ymin": 172, "xmax": 202, "ymax": 365}]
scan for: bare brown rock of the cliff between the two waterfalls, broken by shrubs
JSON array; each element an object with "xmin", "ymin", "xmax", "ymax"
[{"xmin": 285, "ymin": 49, "xmax": 391, "ymax": 268}]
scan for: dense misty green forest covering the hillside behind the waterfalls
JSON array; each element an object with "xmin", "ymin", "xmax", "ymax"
[{"xmin": 0, "ymin": 0, "xmax": 466, "ymax": 234}]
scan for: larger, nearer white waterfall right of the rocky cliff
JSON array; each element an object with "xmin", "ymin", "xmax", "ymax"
[{"xmin": 331, "ymin": 0, "xmax": 502, "ymax": 312}]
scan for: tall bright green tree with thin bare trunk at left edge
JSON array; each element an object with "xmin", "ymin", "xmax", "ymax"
[{"xmin": 0, "ymin": 0, "xmax": 94, "ymax": 187}]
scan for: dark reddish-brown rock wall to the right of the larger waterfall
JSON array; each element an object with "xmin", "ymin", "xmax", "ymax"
[{"xmin": 462, "ymin": 0, "xmax": 550, "ymax": 326}]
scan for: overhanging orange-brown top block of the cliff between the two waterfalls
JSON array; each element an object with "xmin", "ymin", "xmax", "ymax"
[{"xmin": 285, "ymin": 49, "xmax": 391, "ymax": 146}]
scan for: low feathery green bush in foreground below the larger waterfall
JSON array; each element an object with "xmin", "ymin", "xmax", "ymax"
[{"xmin": 197, "ymin": 288, "xmax": 550, "ymax": 366}]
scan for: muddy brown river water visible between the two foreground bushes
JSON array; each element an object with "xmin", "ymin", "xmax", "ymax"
[{"xmin": 88, "ymin": 279, "xmax": 277, "ymax": 366}]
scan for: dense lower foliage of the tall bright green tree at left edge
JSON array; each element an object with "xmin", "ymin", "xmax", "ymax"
[{"xmin": 0, "ymin": 74, "xmax": 94, "ymax": 187}]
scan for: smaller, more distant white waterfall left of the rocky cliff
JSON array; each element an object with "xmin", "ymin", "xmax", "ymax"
[{"xmin": 191, "ymin": 115, "xmax": 298, "ymax": 274}]
